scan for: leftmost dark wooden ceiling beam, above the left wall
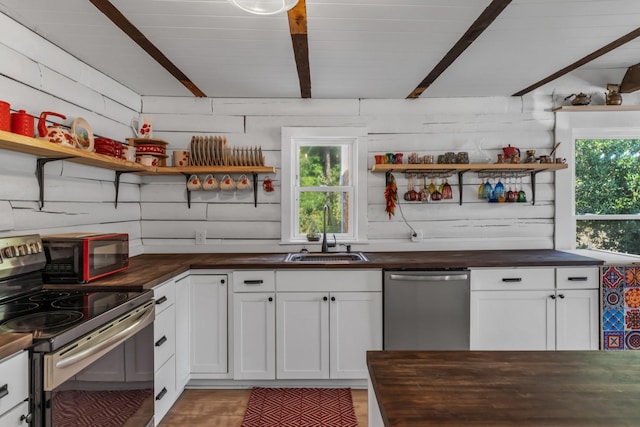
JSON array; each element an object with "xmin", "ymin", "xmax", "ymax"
[{"xmin": 89, "ymin": 0, "xmax": 207, "ymax": 97}]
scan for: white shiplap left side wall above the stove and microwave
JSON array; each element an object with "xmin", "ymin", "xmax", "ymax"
[{"xmin": 0, "ymin": 15, "xmax": 143, "ymax": 254}]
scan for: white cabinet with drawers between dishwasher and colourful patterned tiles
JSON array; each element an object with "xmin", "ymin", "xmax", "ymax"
[{"xmin": 470, "ymin": 267, "xmax": 599, "ymax": 350}]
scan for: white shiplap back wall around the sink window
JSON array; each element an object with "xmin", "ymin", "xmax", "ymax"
[{"xmin": 141, "ymin": 96, "xmax": 562, "ymax": 252}]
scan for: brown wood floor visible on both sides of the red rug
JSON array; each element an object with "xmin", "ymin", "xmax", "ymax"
[{"xmin": 160, "ymin": 389, "xmax": 367, "ymax": 427}]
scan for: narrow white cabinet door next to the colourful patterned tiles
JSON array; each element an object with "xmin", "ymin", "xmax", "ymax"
[{"xmin": 556, "ymin": 289, "xmax": 600, "ymax": 350}]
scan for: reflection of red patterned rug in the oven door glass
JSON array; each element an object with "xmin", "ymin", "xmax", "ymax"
[{"xmin": 53, "ymin": 389, "xmax": 152, "ymax": 427}]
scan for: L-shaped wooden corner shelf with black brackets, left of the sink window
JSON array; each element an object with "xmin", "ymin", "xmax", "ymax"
[{"xmin": 0, "ymin": 130, "xmax": 276, "ymax": 209}]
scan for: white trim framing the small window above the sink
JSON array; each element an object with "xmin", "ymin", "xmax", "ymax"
[{"xmin": 280, "ymin": 127, "xmax": 368, "ymax": 244}]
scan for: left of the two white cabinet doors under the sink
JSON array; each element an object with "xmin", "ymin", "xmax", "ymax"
[{"xmin": 276, "ymin": 292, "xmax": 329, "ymax": 379}]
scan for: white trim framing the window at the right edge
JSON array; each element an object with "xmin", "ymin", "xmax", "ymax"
[{"xmin": 555, "ymin": 111, "xmax": 640, "ymax": 250}]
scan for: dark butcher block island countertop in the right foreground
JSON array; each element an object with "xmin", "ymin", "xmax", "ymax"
[{"xmin": 367, "ymin": 351, "xmax": 640, "ymax": 427}]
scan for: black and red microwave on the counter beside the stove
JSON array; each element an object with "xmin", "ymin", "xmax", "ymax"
[{"xmin": 42, "ymin": 233, "xmax": 129, "ymax": 283}]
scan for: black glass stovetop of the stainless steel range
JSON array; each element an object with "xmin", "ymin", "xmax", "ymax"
[{"xmin": 0, "ymin": 289, "xmax": 149, "ymax": 339}]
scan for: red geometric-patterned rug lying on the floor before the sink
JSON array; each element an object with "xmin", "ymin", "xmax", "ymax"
[{"xmin": 242, "ymin": 387, "xmax": 358, "ymax": 427}]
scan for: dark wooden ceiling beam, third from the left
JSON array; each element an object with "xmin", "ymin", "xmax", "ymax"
[{"xmin": 407, "ymin": 0, "xmax": 511, "ymax": 99}]
